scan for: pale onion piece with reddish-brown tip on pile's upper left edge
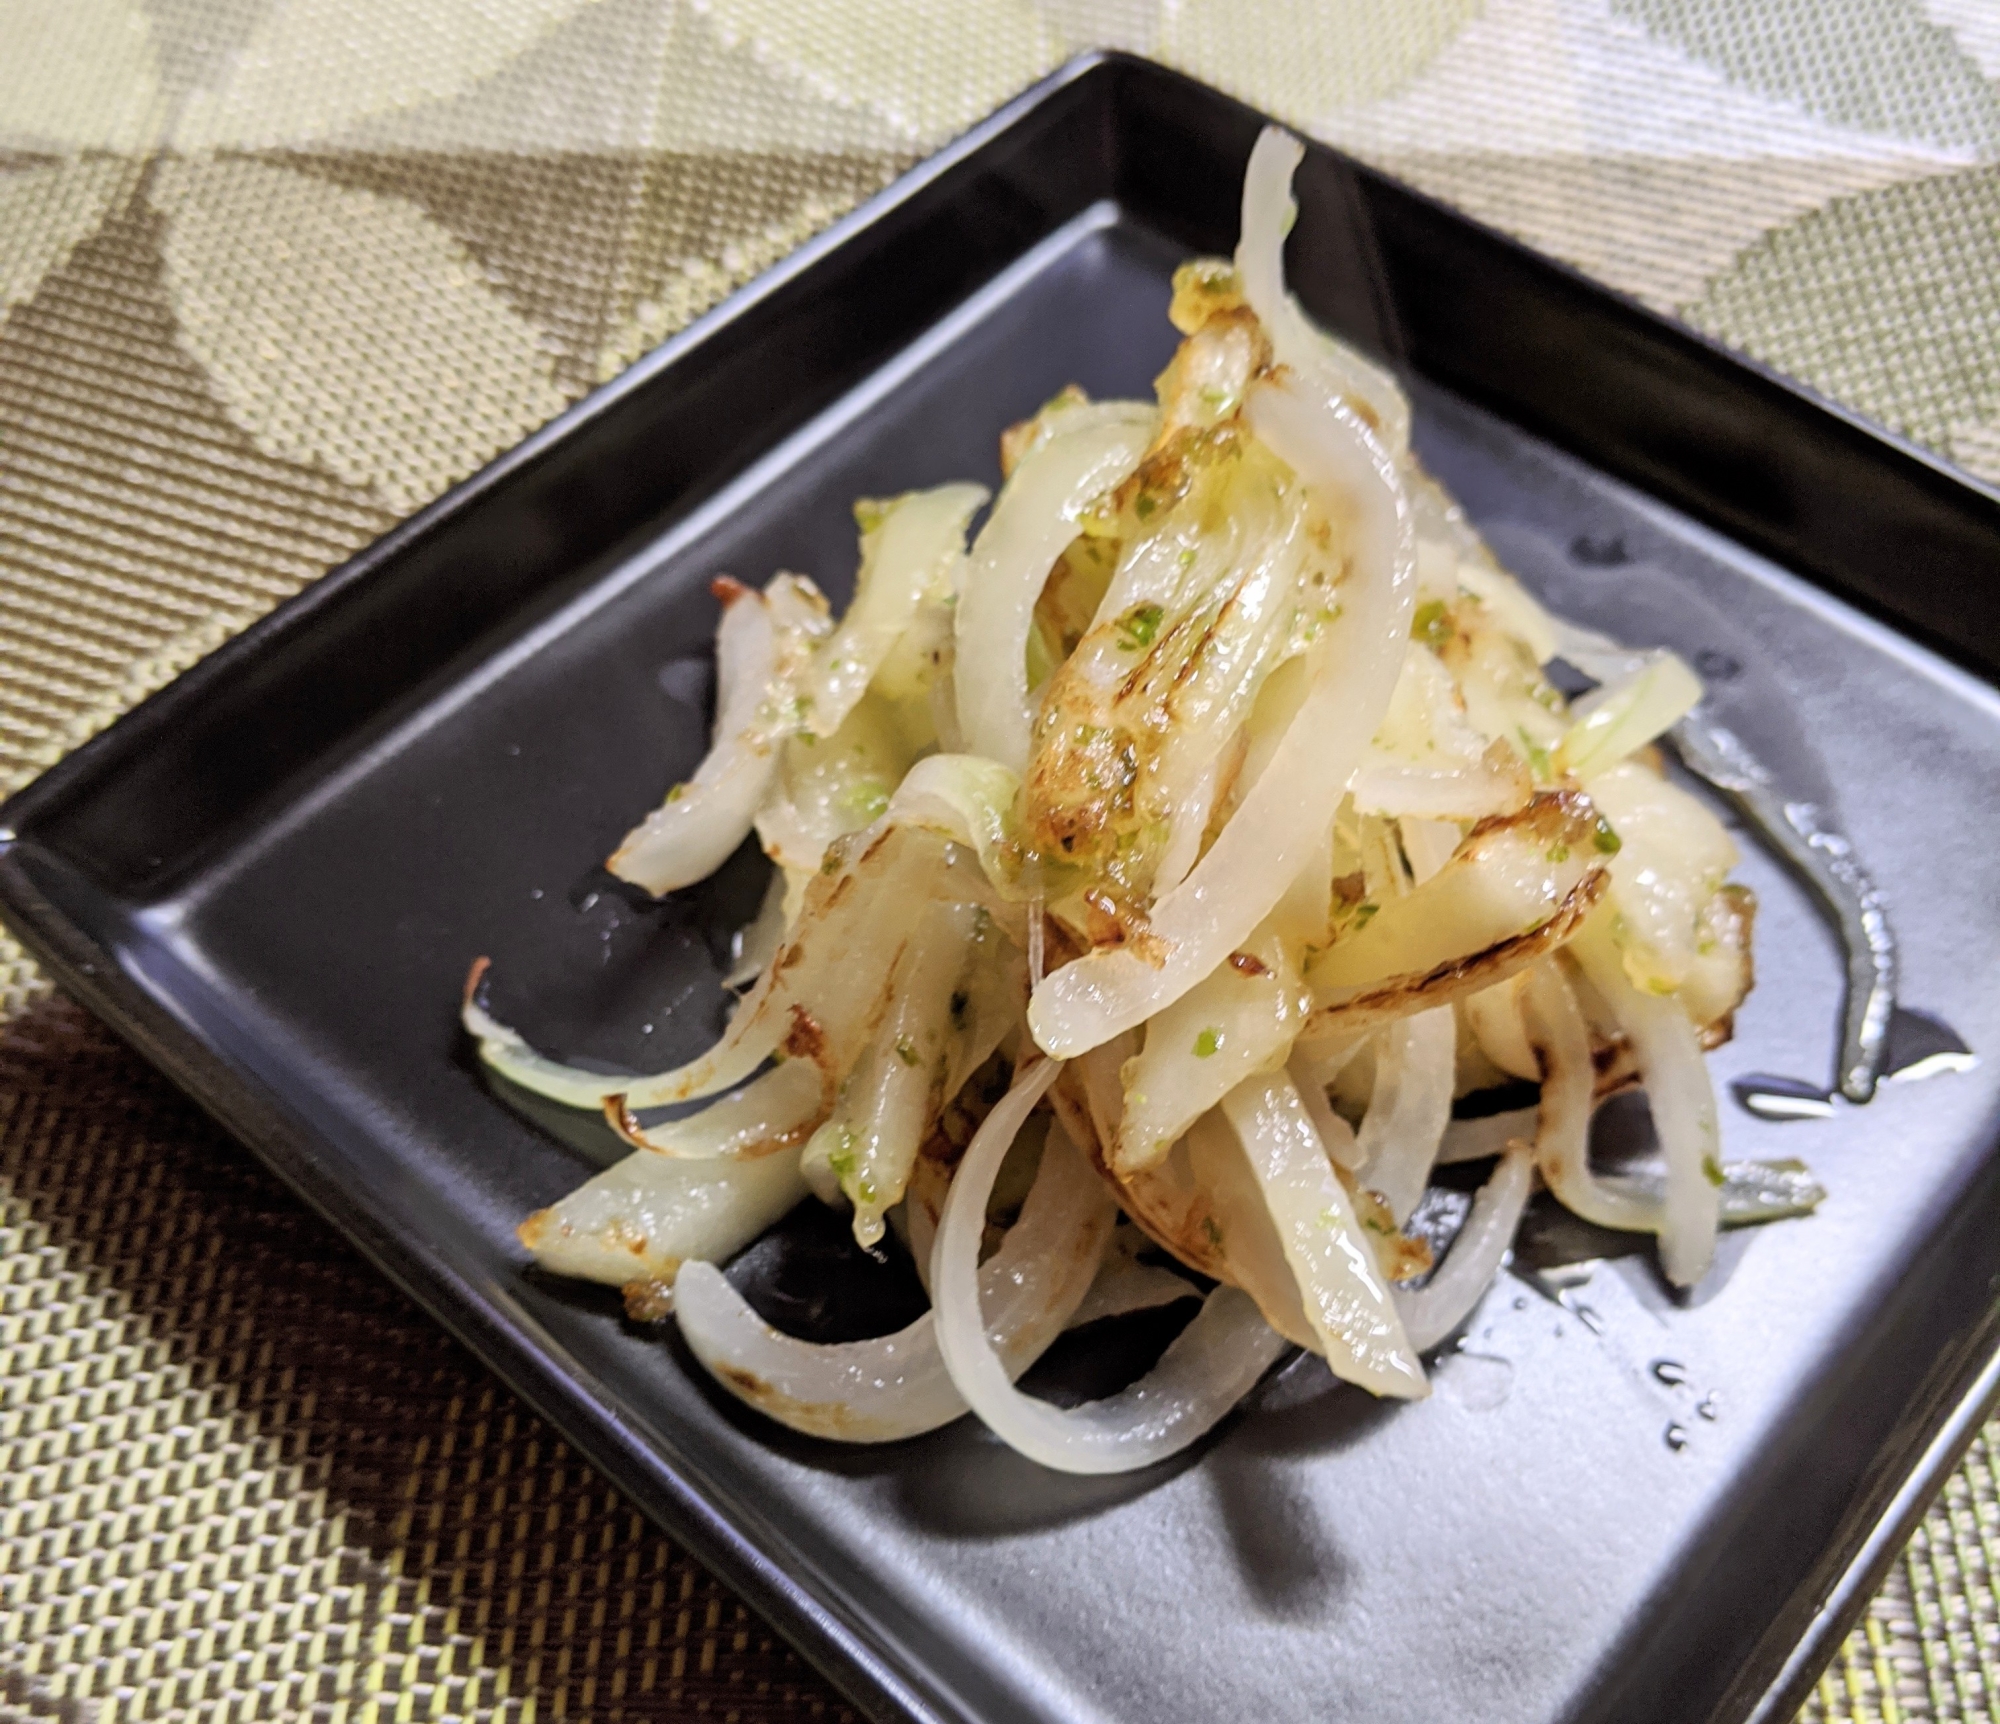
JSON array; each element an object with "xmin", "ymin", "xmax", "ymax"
[{"xmin": 604, "ymin": 576, "xmax": 824, "ymax": 894}]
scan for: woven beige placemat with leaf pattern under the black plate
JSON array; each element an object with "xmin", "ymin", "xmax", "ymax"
[{"xmin": 0, "ymin": 0, "xmax": 2000, "ymax": 1724}]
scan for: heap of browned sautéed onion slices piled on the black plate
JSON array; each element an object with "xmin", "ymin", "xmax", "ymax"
[{"xmin": 464, "ymin": 130, "xmax": 1818, "ymax": 1472}]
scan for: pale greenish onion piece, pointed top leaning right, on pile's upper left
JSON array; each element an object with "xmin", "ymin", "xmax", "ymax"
[{"xmin": 806, "ymin": 484, "xmax": 990, "ymax": 736}]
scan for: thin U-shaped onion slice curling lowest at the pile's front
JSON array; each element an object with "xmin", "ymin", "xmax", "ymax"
[{"xmin": 930, "ymin": 1060, "xmax": 1284, "ymax": 1474}]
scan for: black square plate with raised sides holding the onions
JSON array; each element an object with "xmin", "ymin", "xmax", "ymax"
[{"xmin": 0, "ymin": 56, "xmax": 2000, "ymax": 1724}]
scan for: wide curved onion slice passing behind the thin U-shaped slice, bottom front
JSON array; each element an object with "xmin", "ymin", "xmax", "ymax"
[{"xmin": 674, "ymin": 1104, "xmax": 1116, "ymax": 1442}]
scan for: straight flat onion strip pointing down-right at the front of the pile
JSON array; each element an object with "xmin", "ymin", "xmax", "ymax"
[{"xmin": 1222, "ymin": 1072, "xmax": 1430, "ymax": 1400}]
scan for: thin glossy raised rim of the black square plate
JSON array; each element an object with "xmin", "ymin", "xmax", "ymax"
[{"xmin": 0, "ymin": 50, "xmax": 2000, "ymax": 1724}]
